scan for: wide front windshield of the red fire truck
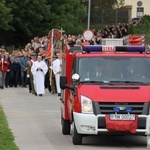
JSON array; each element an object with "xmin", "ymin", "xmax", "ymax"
[{"xmin": 78, "ymin": 57, "xmax": 150, "ymax": 84}]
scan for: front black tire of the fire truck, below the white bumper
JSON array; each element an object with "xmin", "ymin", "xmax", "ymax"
[{"xmin": 72, "ymin": 123, "xmax": 82, "ymax": 145}]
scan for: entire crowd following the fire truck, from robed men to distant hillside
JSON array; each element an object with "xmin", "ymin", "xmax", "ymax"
[{"xmin": 0, "ymin": 21, "xmax": 140, "ymax": 96}]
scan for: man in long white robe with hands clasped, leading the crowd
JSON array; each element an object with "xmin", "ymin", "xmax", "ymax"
[{"xmin": 31, "ymin": 56, "xmax": 48, "ymax": 96}]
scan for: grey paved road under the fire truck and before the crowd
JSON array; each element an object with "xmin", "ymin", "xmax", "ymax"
[{"xmin": 0, "ymin": 88, "xmax": 146, "ymax": 150}]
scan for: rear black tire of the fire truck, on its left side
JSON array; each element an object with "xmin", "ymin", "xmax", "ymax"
[{"xmin": 61, "ymin": 117, "xmax": 70, "ymax": 135}]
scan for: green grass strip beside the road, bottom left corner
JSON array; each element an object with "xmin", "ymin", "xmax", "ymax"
[{"xmin": 0, "ymin": 106, "xmax": 19, "ymax": 150}]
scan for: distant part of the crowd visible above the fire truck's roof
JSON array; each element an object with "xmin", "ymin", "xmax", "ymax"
[{"xmin": 63, "ymin": 20, "xmax": 141, "ymax": 46}]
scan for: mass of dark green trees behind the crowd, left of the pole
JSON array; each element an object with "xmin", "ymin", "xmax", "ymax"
[{"xmin": 0, "ymin": 0, "xmax": 86, "ymax": 47}]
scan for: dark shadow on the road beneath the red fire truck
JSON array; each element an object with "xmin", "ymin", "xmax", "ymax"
[{"xmin": 83, "ymin": 135, "xmax": 147, "ymax": 148}]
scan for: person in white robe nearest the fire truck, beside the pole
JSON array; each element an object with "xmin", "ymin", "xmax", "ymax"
[{"xmin": 52, "ymin": 53, "xmax": 62, "ymax": 96}]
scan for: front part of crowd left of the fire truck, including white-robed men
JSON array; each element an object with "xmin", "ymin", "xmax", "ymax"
[{"xmin": 0, "ymin": 43, "xmax": 61, "ymax": 96}]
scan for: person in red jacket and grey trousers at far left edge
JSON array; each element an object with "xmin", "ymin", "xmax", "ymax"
[{"xmin": 0, "ymin": 49, "xmax": 10, "ymax": 89}]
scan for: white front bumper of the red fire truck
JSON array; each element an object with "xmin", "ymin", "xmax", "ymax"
[{"xmin": 73, "ymin": 112, "xmax": 150, "ymax": 135}]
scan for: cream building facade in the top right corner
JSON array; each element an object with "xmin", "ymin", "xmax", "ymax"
[{"xmin": 124, "ymin": 0, "xmax": 150, "ymax": 18}]
